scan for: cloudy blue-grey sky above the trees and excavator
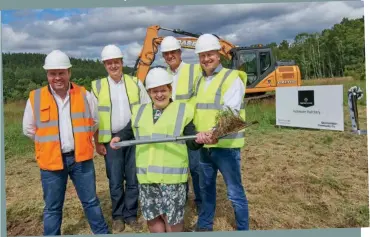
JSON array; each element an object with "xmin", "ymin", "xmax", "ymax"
[{"xmin": 2, "ymin": 1, "xmax": 364, "ymax": 66}]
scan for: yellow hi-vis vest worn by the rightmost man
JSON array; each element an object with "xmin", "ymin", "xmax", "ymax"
[{"xmin": 194, "ymin": 68, "xmax": 247, "ymax": 148}]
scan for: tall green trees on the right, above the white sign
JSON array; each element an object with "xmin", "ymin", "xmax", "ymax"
[{"xmin": 267, "ymin": 17, "xmax": 365, "ymax": 80}]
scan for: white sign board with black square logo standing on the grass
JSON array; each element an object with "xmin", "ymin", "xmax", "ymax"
[{"xmin": 276, "ymin": 85, "xmax": 344, "ymax": 131}]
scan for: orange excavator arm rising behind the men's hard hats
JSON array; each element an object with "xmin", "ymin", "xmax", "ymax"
[{"xmin": 132, "ymin": 25, "xmax": 235, "ymax": 82}]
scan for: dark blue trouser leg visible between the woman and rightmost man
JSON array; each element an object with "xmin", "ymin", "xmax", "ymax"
[{"xmin": 186, "ymin": 149, "xmax": 202, "ymax": 212}]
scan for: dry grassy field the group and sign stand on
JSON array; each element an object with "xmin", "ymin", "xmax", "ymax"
[{"xmin": 5, "ymin": 78, "xmax": 369, "ymax": 236}]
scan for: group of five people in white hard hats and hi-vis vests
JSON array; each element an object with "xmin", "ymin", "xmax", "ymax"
[{"xmin": 23, "ymin": 34, "xmax": 249, "ymax": 235}]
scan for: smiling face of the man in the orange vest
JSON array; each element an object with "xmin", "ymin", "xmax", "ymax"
[{"xmin": 46, "ymin": 69, "xmax": 71, "ymax": 94}]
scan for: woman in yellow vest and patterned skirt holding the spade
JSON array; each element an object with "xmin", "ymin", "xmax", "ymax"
[{"xmin": 111, "ymin": 68, "xmax": 217, "ymax": 233}]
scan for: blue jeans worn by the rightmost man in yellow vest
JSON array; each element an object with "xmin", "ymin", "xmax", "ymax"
[{"xmin": 197, "ymin": 148, "xmax": 249, "ymax": 231}]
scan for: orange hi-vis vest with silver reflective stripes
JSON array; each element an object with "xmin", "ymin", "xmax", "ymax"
[{"xmin": 30, "ymin": 83, "xmax": 94, "ymax": 170}]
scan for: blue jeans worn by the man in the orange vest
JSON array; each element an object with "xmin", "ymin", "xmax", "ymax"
[{"xmin": 40, "ymin": 155, "xmax": 109, "ymax": 235}]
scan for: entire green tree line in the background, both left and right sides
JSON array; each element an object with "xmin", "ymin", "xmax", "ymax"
[{"xmin": 3, "ymin": 17, "xmax": 365, "ymax": 102}]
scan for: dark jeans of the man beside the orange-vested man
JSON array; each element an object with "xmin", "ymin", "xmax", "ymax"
[{"xmin": 104, "ymin": 138, "xmax": 139, "ymax": 223}]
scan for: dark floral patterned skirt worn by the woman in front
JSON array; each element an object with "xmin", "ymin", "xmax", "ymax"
[{"xmin": 139, "ymin": 183, "xmax": 186, "ymax": 225}]
